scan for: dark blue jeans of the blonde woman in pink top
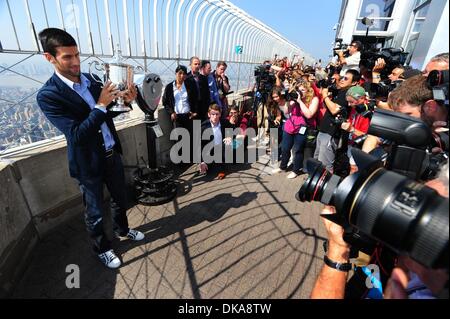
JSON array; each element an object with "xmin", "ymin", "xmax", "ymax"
[{"xmin": 280, "ymin": 131, "xmax": 306, "ymax": 174}]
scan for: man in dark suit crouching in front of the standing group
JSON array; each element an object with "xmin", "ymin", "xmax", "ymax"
[{"xmin": 199, "ymin": 104, "xmax": 233, "ymax": 179}]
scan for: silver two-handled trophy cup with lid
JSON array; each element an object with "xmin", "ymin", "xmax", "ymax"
[{"xmin": 89, "ymin": 45, "xmax": 143, "ymax": 112}]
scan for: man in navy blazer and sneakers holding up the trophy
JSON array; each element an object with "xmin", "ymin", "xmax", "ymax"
[{"xmin": 37, "ymin": 28, "xmax": 144, "ymax": 268}]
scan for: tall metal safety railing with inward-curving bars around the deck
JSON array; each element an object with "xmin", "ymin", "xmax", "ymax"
[{"xmin": 0, "ymin": 0, "xmax": 312, "ymax": 157}]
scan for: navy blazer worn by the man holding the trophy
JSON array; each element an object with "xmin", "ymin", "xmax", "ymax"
[{"xmin": 37, "ymin": 74, "xmax": 122, "ymax": 178}]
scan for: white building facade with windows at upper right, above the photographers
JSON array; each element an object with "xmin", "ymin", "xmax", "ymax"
[{"xmin": 336, "ymin": 0, "xmax": 449, "ymax": 69}]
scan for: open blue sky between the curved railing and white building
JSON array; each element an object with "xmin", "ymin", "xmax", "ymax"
[{"xmin": 230, "ymin": 0, "xmax": 341, "ymax": 61}]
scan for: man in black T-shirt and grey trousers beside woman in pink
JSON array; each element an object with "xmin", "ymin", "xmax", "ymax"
[{"xmin": 314, "ymin": 70, "xmax": 360, "ymax": 172}]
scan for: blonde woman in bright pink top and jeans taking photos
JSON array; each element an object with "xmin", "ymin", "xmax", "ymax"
[{"xmin": 272, "ymin": 81, "xmax": 319, "ymax": 179}]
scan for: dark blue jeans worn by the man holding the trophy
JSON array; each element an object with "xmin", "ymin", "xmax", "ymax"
[{"xmin": 78, "ymin": 153, "xmax": 129, "ymax": 254}]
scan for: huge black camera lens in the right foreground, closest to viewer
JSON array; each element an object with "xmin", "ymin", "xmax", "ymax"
[{"xmin": 296, "ymin": 149, "xmax": 449, "ymax": 269}]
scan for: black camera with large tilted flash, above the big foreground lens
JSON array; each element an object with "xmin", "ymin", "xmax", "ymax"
[{"xmin": 368, "ymin": 109, "xmax": 448, "ymax": 181}]
